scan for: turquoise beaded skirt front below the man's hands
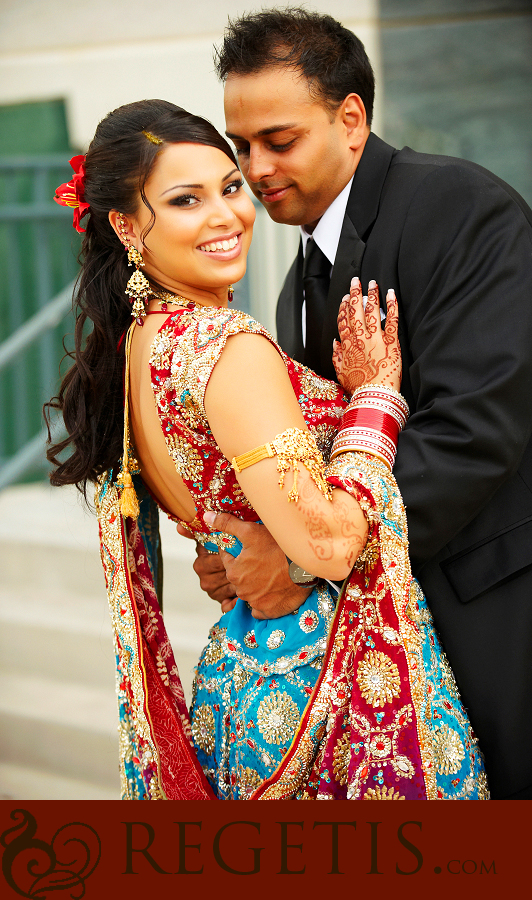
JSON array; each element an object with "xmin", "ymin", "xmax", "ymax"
[{"xmin": 191, "ymin": 587, "xmax": 334, "ymax": 800}]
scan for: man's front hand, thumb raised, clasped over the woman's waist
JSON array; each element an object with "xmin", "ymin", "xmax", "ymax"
[{"xmin": 203, "ymin": 513, "xmax": 312, "ymax": 619}]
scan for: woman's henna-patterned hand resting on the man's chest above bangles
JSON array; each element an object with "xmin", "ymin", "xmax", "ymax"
[{"xmin": 333, "ymin": 278, "xmax": 401, "ymax": 394}]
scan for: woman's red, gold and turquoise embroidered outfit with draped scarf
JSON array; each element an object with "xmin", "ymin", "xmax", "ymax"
[{"xmin": 96, "ymin": 307, "xmax": 489, "ymax": 800}]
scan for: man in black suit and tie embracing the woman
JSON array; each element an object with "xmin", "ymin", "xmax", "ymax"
[{"xmin": 186, "ymin": 10, "xmax": 532, "ymax": 799}]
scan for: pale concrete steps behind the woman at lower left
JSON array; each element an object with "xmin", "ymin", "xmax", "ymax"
[{"xmin": 0, "ymin": 484, "xmax": 220, "ymax": 799}]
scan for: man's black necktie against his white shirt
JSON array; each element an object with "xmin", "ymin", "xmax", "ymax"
[{"xmin": 303, "ymin": 238, "xmax": 332, "ymax": 369}]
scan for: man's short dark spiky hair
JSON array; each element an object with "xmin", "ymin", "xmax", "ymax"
[{"xmin": 214, "ymin": 8, "xmax": 375, "ymax": 124}]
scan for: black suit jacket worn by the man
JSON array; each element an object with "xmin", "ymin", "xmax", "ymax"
[{"xmin": 277, "ymin": 134, "xmax": 532, "ymax": 797}]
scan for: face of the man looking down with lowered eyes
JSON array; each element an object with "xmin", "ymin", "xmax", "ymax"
[{"xmin": 224, "ymin": 66, "xmax": 356, "ymax": 226}]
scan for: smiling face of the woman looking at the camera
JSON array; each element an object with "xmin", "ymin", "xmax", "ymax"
[{"xmin": 130, "ymin": 144, "xmax": 255, "ymax": 293}]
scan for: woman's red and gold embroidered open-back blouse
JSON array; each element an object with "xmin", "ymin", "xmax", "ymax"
[{"xmin": 150, "ymin": 307, "xmax": 348, "ymax": 540}]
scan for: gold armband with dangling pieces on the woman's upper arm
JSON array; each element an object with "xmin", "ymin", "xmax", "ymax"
[{"xmin": 231, "ymin": 428, "xmax": 331, "ymax": 503}]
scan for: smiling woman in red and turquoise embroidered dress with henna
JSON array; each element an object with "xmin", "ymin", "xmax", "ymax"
[{"xmin": 48, "ymin": 100, "xmax": 489, "ymax": 799}]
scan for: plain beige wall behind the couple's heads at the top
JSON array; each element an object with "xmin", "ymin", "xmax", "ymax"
[{"xmin": 0, "ymin": 0, "xmax": 380, "ymax": 149}]
